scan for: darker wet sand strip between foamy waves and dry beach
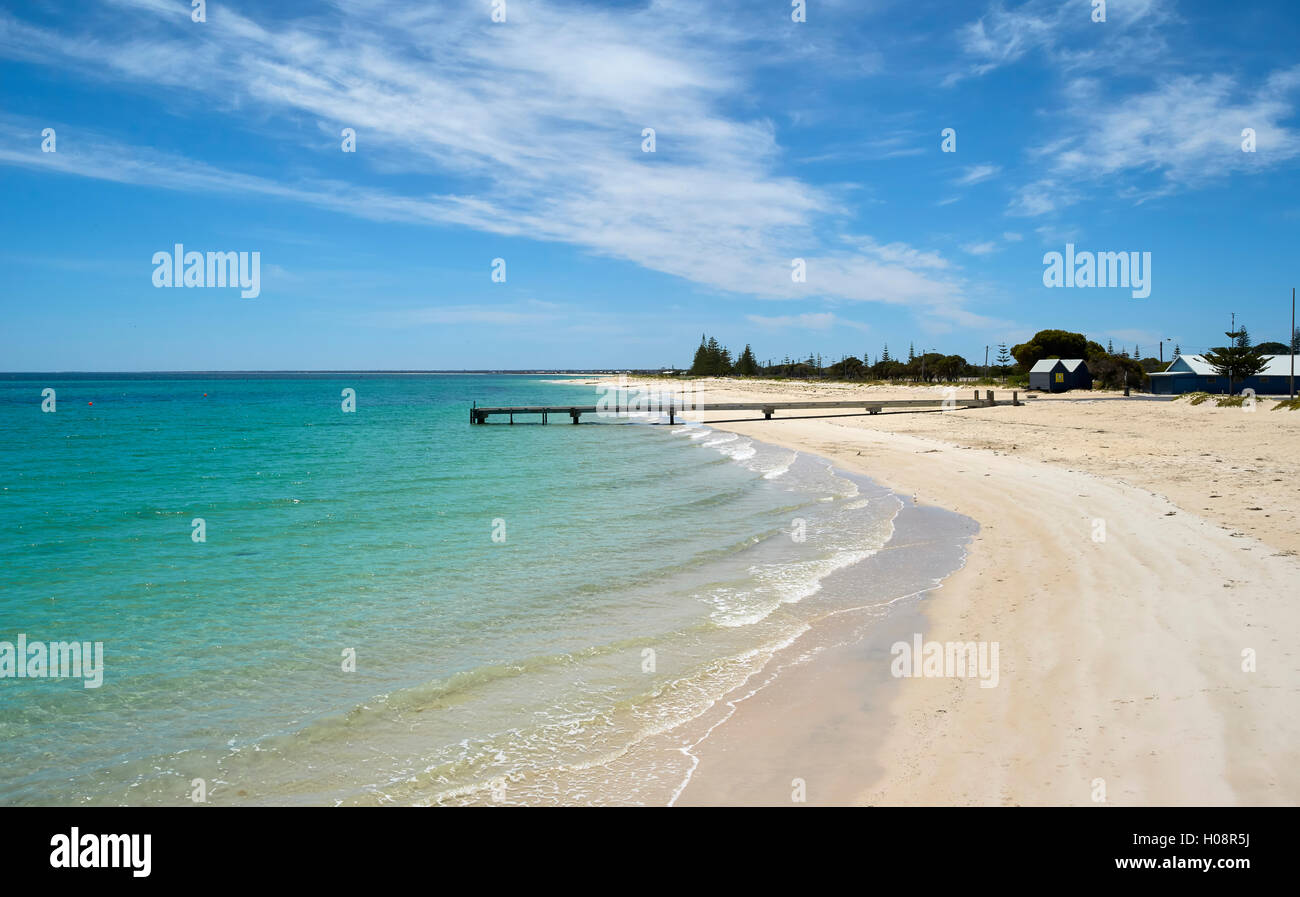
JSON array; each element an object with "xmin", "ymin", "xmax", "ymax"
[{"xmin": 672, "ymin": 491, "xmax": 978, "ymax": 806}]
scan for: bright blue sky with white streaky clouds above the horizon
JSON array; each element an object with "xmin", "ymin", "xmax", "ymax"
[{"xmin": 0, "ymin": 0, "xmax": 1300, "ymax": 371}]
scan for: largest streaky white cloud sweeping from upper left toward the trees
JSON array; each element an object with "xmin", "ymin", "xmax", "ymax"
[{"xmin": 0, "ymin": 0, "xmax": 965, "ymax": 321}]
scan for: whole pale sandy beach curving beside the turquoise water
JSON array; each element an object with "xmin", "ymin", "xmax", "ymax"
[{"xmin": 595, "ymin": 380, "xmax": 1300, "ymax": 805}]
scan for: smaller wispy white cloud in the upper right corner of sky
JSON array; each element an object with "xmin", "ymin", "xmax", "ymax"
[{"xmin": 945, "ymin": 0, "xmax": 1300, "ymax": 217}]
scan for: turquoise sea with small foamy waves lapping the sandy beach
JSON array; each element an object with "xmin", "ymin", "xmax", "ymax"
[{"xmin": 0, "ymin": 374, "xmax": 970, "ymax": 805}]
